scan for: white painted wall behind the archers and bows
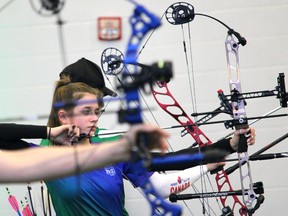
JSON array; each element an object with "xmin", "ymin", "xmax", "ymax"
[{"xmin": 0, "ymin": 0, "xmax": 288, "ymax": 216}]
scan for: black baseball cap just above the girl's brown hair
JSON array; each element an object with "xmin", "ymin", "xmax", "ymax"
[{"xmin": 59, "ymin": 58, "xmax": 117, "ymax": 97}]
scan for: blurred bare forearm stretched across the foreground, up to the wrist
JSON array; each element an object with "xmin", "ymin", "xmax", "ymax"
[{"xmin": 0, "ymin": 140, "xmax": 130, "ymax": 183}]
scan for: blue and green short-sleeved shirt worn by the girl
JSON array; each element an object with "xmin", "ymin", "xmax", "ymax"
[{"xmin": 41, "ymin": 130, "xmax": 152, "ymax": 216}]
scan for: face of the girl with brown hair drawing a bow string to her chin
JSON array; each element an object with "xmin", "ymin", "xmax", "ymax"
[{"xmin": 67, "ymin": 93, "xmax": 101, "ymax": 136}]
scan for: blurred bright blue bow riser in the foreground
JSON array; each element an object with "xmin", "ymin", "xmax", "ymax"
[{"xmin": 120, "ymin": 2, "xmax": 181, "ymax": 216}]
